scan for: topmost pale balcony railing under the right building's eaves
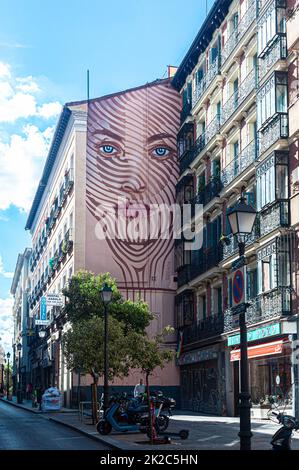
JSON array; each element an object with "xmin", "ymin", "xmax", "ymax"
[{"xmin": 221, "ymin": 0, "xmax": 257, "ymax": 65}]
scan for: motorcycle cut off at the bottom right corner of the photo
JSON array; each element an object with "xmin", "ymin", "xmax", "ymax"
[{"xmin": 269, "ymin": 410, "xmax": 299, "ymax": 450}]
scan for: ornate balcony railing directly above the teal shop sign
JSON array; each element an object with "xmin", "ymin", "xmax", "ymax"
[{"xmin": 224, "ymin": 287, "xmax": 292, "ymax": 333}]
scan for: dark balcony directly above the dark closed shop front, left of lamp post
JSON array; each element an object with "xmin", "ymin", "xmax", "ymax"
[{"xmin": 183, "ymin": 314, "xmax": 224, "ymax": 345}]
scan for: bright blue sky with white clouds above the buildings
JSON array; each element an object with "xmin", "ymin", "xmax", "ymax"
[{"xmin": 0, "ymin": 0, "xmax": 214, "ymax": 351}]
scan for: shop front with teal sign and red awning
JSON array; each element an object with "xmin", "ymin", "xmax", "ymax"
[{"xmin": 228, "ymin": 323, "xmax": 292, "ymax": 419}]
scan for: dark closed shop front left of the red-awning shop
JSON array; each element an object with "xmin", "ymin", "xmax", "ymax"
[{"xmin": 178, "ymin": 344, "xmax": 225, "ymax": 415}]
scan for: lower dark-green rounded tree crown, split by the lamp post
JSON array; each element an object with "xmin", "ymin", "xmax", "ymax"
[{"xmin": 63, "ymin": 317, "xmax": 132, "ymax": 379}]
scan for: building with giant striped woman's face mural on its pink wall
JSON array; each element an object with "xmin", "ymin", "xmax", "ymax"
[{"xmin": 26, "ymin": 80, "xmax": 180, "ymax": 406}]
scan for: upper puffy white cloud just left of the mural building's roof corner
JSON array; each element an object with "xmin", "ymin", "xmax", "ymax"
[{"xmin": 0, "ymin": 62, "xmax": 61, "ymax": 123}]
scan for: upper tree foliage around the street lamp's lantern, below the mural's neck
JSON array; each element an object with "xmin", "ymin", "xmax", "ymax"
[{"xmin": 63, "ymin": 271, "xmax": 153, "ymax": 333}]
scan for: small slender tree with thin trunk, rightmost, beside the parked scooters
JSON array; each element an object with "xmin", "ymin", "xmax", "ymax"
[{"xmin": 132, "ymin": 326, "xmax": 174, "ymax": 444}]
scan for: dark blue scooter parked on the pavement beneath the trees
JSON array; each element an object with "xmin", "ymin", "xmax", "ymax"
[{"xmin": 96, "ymin": 393, "xmax": 176, "ymax": 435}]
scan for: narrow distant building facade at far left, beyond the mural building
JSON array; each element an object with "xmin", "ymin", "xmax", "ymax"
[{"xmin": 10, "ymin": 248, "xmax": 32, "ymax": 396}]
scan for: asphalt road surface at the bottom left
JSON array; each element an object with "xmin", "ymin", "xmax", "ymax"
[{"xmin": 0, "ymin": 402, "xmax": 108, "ymax": 450}]
